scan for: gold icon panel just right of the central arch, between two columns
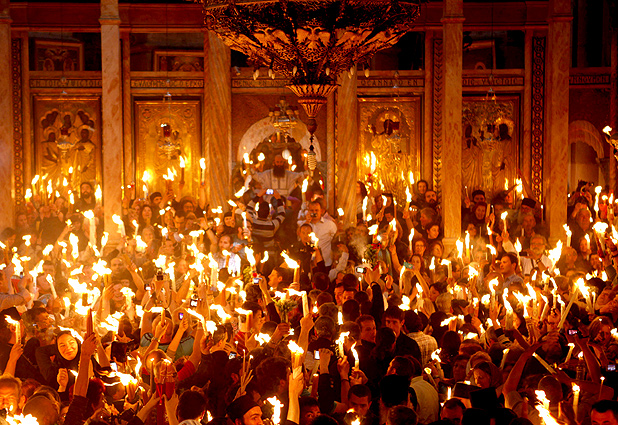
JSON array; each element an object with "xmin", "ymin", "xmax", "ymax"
[{"xmin": 359, "ymin": 97, "xmax": 422, "ymax": 205}]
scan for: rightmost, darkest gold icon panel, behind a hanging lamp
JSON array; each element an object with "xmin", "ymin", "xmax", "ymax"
[{"xmin": 461, "ymin": 96, "xmax": 520, "ymax": 199}]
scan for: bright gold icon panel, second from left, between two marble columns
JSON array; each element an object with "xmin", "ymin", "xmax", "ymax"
[{"xmin": 135, "ymin": 100, "xmax": 202, "ymax": 198}]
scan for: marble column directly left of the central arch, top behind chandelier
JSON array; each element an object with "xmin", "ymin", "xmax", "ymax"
[{"xmin": 204, "ymin": 32, "xmax": 232, "ymax": 208}]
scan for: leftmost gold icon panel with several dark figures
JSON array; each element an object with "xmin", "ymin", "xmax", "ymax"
[{"xmin": 31, "ymin": 96, "xmax": 102, "ymax": 195}]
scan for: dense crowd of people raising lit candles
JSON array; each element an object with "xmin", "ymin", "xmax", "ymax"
[{"xmin": 0, "ymin": 157, "xmax": 618, "ymax": 425}]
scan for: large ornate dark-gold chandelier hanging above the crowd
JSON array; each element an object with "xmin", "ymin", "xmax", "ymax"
[{"xmin": 194, "ymin": 0, "xmax": 420, "ymax": 140}]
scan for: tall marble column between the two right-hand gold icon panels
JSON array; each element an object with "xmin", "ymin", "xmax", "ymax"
[{"xmin": 441, "ymin": 0, "xmax": 464, "ymax": 248}]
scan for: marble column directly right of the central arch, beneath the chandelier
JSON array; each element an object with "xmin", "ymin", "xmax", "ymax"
[{"xmin": 335, "ymin": 72, "xmax": 359, "ymax": 226}]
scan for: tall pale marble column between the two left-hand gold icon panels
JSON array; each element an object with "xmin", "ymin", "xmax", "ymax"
[{"xmin": 99, "ymin": 0, "xmax": 123, "ymax": 247}]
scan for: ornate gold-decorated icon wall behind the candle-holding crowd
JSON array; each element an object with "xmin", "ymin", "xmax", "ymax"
[{"xmin": 2, "ymin": 2, "xmax": 615, "ymax": 232}]
